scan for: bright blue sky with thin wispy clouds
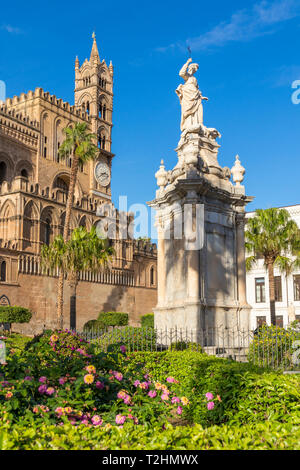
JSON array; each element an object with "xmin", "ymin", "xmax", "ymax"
[{"xmin": 0, "ymin": 0, "xmax": 300, "ymax": 237}]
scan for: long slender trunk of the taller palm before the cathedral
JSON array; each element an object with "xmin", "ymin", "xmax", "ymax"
[{"xmin": 57, "ymin": 154, "xmax": 79, "ymax": 329}]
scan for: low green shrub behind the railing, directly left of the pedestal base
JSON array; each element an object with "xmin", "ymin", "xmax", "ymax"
[{"xmin": 94, "ymin": 326, "xmax": 156, "ymax": 352}]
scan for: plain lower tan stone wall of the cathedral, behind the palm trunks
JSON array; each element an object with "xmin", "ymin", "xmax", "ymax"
[{"xmin": 0, "ymin": 273, "xmax": 157, "ymax": 335}]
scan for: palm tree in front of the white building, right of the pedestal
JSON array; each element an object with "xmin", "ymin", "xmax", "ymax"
[{"xmin": 245, "ymin": 208, "xmax": 300, "ymax": 325}]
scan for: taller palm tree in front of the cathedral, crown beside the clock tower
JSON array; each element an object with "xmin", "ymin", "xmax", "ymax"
[{"xmin": 57, "ymin": 122, "xmax": 98, "ymax": 328}]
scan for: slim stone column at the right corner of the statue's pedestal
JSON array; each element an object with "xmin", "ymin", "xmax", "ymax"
[{"xmin": 236, "ymin": 214, "xmax": 247, "ymax": 306}]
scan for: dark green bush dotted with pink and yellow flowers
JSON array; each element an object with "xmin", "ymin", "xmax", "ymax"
[{"xmin": 0, "ymin": 331, "xmax": 189, "ymax": 426}]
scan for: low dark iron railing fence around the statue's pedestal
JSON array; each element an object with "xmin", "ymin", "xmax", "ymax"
[{"xmin": 79, "ymin": 327, "xmax": 300, "ymax": 371}]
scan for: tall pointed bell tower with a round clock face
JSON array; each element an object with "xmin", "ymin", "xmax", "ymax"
[{"xmin": 75, "ymin": 33, "xmax": 114, "ymax": 199}]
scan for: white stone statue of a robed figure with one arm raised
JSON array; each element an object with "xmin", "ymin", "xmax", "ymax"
[{"xmin": 176, "ymin": 59, "xmax": 208, "ymax": 132}]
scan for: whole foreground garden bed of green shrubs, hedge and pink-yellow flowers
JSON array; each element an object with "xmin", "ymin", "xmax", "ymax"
[{"xmin": 0, "ymin": 328, "xmax": 300, "ymax": 449}]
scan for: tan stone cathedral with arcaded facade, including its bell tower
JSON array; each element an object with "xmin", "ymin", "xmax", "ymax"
[{"xmin": 0, "ymin": 36, "xmax": 157, "ymax": 333}]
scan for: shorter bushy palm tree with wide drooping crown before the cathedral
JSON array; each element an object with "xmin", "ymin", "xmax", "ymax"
[{"xmin": 41, "ymin": 227, "xmax": 114, "ymax": 329}]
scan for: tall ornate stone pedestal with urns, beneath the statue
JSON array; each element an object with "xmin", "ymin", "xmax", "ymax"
[{"xmin": 148, "ymin": 125, "xmax": 253, "ymax": 335}]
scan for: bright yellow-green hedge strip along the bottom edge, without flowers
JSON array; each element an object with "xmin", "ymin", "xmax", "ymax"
[{"xmin": 0, "ymin": 422, "xmax": 300, "ymax": 450}]
